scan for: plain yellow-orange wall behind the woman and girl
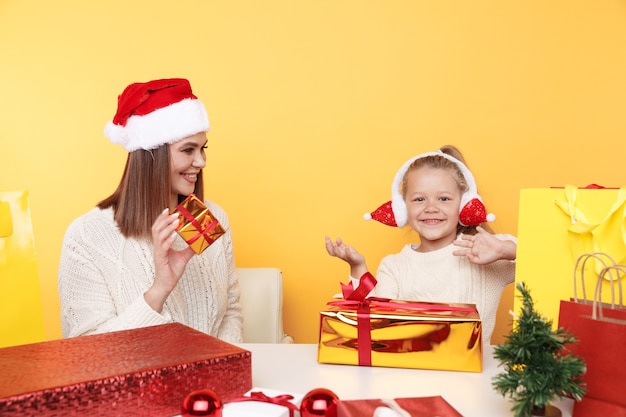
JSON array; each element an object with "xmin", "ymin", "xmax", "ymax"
[{"xmin": 0, "ymin": 0, "xmax": 626, "ymax": 343}]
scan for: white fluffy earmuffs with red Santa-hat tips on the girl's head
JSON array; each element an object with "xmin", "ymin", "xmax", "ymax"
[{"xmin": 364, "ymin": 150, "xmax": 496, "ymax": 227}]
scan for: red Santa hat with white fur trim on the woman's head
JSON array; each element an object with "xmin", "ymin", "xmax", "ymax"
[{"xmin": 104, "ymin": 78, "xmax": 209, "ymax": 152}]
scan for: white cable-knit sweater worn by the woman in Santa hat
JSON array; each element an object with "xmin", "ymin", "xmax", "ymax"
[{"xmin": 59, "ymin": 202, "xmax": 242, "ymax": 343}]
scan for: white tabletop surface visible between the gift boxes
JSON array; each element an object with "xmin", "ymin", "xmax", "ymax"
[{"xmin": 238, "ymin": 343, "xmax": 573, "ymax": 417}]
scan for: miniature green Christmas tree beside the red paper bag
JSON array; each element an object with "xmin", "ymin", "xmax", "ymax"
[{"xmin": 492, "ymin": 282, "xmax": 585, "ymax": 417}]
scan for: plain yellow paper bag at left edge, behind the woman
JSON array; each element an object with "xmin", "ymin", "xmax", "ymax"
[{"xmin": 0, "ymin": 191, "xmax": 44, "ymax": 348}]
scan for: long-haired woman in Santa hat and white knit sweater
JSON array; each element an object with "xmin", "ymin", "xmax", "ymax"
[{"xmin": 59, "ymin": 79, "xmax": 242, "ymax": 342}]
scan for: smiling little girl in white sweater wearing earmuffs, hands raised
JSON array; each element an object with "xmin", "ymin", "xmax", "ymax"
[{"xmin": 326, "ymin": 146, "xmax": 517, "ymax": 343}]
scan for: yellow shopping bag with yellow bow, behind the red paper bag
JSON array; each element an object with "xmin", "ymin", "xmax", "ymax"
[{"xmin": 514, "ymin": 186, "xmax": 626, "ymax": 327}]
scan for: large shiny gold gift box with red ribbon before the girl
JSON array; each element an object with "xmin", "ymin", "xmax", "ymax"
[{"xmin": 318, "ymin": 298, "xmax": 483, "ymax": 372}]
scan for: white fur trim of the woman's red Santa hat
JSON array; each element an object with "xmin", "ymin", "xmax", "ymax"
[{"xmin": 104, "ymin": 99, "xmax": 210, "ymax": 152}]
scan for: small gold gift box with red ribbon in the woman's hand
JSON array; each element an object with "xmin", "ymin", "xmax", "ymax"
[{"xmin": 176, "ymin": 194, "xmax": 226, "ymax": 255}]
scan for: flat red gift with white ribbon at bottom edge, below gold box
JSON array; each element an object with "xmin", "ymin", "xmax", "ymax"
[{"xmin": 337, "ymin": 396, "xmax": 462, "ymax": 417}]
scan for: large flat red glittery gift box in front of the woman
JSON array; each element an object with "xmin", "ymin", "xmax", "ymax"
[{"xmin": 0, "ymin": 323, "xmax": 252, "ymax": 417}]
